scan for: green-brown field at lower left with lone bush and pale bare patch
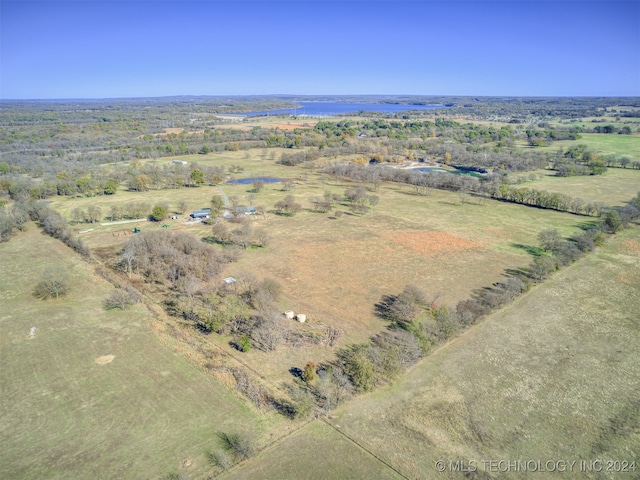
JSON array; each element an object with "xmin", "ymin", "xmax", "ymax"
[{"xmin": 0, "ymin": 226, "xmax": 281, "ymax": 479}]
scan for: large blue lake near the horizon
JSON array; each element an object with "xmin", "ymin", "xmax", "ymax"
[{"xmin": 237, "ymin": 102, "xmax": 447, "ymax": 117}]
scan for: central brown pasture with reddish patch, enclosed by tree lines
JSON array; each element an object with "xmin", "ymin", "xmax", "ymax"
[{"xmin": 54, "ymin": 156, "xmax": 588, "ymax": 380}]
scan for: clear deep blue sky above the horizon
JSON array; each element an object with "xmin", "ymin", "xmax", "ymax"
[{"xmin": 0, "ymin": 0, "xmax": 640, "ymax": 99}]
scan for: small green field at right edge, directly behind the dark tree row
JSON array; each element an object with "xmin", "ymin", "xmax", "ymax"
[{"xmin": 522, "ymin": 168, "xmax": 640, "ymax": 206}]
